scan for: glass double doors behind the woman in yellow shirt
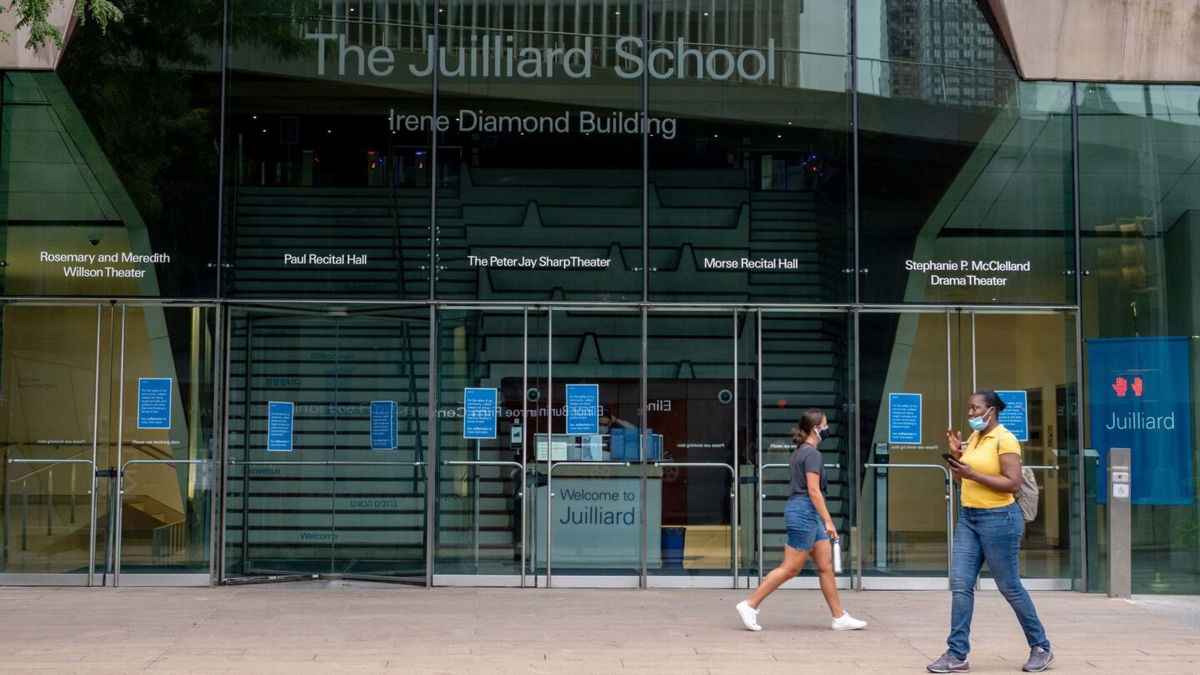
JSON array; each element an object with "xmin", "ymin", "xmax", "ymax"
[{"xmin": 859, "ymin": 310, "xmax": 1078, "ymax": 589}]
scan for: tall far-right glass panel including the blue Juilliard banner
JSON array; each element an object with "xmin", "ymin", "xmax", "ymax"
[{"xmin": 1076, "ymin": 84, "xmax": 1200, "ymax": 593}]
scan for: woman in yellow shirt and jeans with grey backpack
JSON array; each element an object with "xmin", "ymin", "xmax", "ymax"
[{"xmin": 926, "ymin": 390, "xmax": 1054, "ymax": 673}]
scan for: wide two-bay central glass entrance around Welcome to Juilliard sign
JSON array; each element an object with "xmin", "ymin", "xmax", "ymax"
[{"xmin": 433, "ymin": 306, "xmax": 854, "ymax": 587}]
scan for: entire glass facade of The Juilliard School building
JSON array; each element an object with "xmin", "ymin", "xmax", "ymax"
[{"xmin": 0, "ymin": 0, "xmax": 1200, "ymax": 592}]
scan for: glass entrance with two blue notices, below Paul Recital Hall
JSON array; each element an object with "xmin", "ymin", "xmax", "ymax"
[{"xmin": 224, "ymin": 306, "xmax": 430, "ymax": 583}]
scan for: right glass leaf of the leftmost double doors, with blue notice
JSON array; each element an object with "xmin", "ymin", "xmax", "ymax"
[{"xmin": 113, "ymin": 306, "xmax": 217, "ymax": 575}]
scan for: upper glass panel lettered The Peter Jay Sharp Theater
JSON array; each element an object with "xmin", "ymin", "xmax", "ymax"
[{"xmin": 434, "ymin": 0, "xmax": 644, "ymax": 300}]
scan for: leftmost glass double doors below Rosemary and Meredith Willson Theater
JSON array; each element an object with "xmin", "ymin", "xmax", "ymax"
[{"xmin": 0, "ymin": 304, "xmax": 216, "ymax": 585}]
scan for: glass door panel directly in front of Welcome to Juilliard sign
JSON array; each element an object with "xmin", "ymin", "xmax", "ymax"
[{"xmin": 537, "ymin": 309, "xmax": 648, "ymax": 576}]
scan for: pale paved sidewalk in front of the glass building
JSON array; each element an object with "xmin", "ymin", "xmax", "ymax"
[{"xmin": 0, "ymin": 581, "xmax": 1200, "ymax": 675}]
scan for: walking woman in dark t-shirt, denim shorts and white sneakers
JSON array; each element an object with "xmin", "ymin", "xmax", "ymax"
[{"xmin": 737, "ymin": 408, "xmax": 866, "ymax": 631}]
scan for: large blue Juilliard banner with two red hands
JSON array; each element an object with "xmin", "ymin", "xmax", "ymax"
[{"xmin": 1087, "ymin": 338, "xmax": 1195, "ymax": 504}]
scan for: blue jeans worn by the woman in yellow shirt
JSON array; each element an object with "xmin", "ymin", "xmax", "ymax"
[{"xmin": 946, "ymin": 503, "xmax": 1050, "ymax": 658}]
